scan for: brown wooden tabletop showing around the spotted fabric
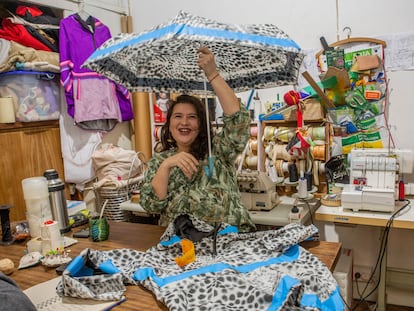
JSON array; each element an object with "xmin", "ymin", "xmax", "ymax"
[{"xmin": 0, "ymin": 222, "xmax": 341, "ymax": 311}]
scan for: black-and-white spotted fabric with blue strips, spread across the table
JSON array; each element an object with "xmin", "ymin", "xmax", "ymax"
[{"xmin": 57, "ymin": 217, "xmax": 344, "ymax": 311}]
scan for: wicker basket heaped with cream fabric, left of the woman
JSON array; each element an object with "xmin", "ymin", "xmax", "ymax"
[{"xmin": 92, "ymin": 144, "xmax": 146, "ymax": 221}]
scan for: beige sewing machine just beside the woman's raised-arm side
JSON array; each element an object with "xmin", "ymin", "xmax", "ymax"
[{"xmin": 237, "ymin": 170, "xmax": 280, "ymax": 211}]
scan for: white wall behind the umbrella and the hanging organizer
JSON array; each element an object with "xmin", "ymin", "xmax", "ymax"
[{"xmin": 130, "ymin": 0, "xmax": 414, "ymax": 182}]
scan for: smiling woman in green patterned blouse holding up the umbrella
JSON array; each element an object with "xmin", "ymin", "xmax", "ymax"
[{"xmin": 140, "ymin": 47, "xmax": 255, "ymax": 231}]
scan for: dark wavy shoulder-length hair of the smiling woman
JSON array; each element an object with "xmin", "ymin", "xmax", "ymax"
[{"xmin": 161, "ymin": 95, "xmax": 213, "ymax": 160}]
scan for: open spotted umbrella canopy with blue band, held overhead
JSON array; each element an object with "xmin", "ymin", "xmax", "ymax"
[{"xmin": 84, "ymin": 12, "xmax": 303, "ymax": 94}]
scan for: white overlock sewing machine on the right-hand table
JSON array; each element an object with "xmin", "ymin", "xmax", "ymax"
[{"xmin": 341, "ymin": 148, "xmax": 413, "ymax": 212}]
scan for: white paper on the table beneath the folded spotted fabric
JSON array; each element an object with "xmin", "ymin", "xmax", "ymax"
[{"xmin": 23, "ymin": 277, "xmax": 125, "ymax": 311}]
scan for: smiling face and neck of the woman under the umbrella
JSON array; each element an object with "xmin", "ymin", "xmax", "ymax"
[{"xmin": 170, "ymin": 103, "xmax": 200, "ymax": 151}]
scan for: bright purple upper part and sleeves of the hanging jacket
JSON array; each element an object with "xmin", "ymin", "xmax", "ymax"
[{"xmin": 59, "ymin": 14, "xmax": 134, "ymax": 121}]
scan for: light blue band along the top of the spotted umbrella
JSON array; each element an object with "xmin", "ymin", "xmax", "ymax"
[{"xmin": 87, "ymin": 24, "xmax": 300, "ymax": 61}]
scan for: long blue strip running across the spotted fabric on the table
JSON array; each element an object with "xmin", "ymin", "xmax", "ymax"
[{"xmin": 133, "ymin": 245, "xmax": 300, "ymax": 287}]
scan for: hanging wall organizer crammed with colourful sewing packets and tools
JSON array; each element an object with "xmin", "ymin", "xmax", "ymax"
[{"xmin": 319, "ymin": 42, "xmax": 388, "ymax": 155}]
